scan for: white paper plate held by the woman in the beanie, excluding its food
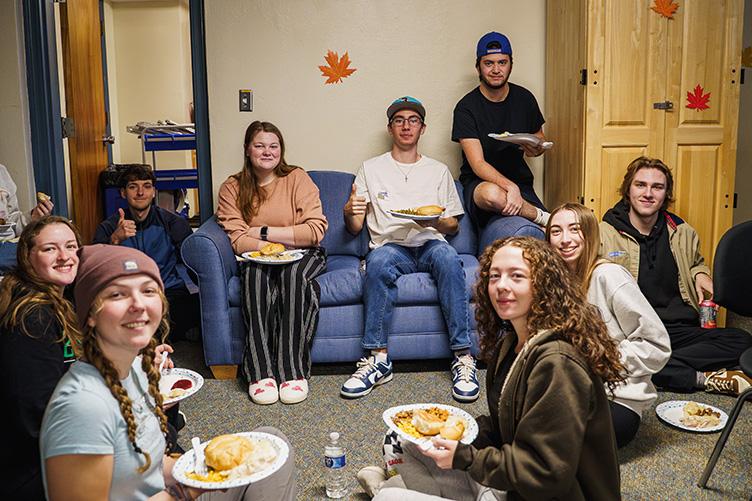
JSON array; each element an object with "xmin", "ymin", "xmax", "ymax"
[{"xmin": 172, "ymin": 431, "xmax": 290, "ymax": 490}]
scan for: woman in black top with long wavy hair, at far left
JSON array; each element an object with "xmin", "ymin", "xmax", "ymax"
[{"xmin": 0, "ymin": 216, "xmax": 81, "ymax": 500}]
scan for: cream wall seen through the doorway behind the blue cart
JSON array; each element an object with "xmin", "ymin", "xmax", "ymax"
[{"xmin": 104, "ymin": 0, "xmax": 193, "ymax": 169}]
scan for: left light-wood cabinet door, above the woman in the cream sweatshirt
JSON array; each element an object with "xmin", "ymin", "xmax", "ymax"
[{"xmin": 584, "ymin": 0, "xmax": 668, "ymax": 217}]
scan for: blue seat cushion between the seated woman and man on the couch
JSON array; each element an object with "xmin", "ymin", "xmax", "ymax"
[{"xmin": 316, "ymin": 256, "xmax": 363, "ymax": 308}]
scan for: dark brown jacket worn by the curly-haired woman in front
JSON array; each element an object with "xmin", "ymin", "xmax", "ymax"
[{"xmin": 452, "ymin": 331, "xmax": 621, "ymax": 501}]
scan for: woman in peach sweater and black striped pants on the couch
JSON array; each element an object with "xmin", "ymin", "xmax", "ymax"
[{"xmin": 217, "ymin": 121, "xmax": 327, "ymax": 404}]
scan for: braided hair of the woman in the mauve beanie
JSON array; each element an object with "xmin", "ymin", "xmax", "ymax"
[{"xmin": 82, "ymin": 290, "xmax": 170, "ymax": 473}]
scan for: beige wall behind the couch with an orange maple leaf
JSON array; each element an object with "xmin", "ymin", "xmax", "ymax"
[{"xmin": 206, "ymin": 0, "xmax": 555, "ymax": 203}]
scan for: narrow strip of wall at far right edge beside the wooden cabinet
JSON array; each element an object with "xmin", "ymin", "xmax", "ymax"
[{"xmin": 734, "ymin": 0, "xmax": 752, "ymax": 224}]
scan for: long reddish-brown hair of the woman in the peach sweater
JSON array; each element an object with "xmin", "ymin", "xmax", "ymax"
[{"xmin": 232, "ymin": 120, "xmax": 300, "ymax": 223}]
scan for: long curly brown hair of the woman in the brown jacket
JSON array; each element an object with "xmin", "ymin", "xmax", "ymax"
[{"xmin": 475, "ymin": 237, "xmax": 625, "ymax": 389}]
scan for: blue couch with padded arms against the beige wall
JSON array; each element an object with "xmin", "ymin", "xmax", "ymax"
[{"xmin": 182, "ymin": 171, "xmax": 542, "ymax": 378}]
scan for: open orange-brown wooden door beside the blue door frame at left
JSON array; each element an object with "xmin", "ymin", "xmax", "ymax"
[{"xmin": 60, "ymin": 0, "xmax": 108, "ymax": 243}]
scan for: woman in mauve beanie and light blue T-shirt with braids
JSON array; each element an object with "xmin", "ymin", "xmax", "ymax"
[{"xmin": 40, "ymin": 245, "xmax": 295, "ymax": 501}]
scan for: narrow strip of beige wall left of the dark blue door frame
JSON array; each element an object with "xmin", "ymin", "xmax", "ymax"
[{"xmin": 0, "ymin": 0, "xmax": 35, "ymax": 210}]
